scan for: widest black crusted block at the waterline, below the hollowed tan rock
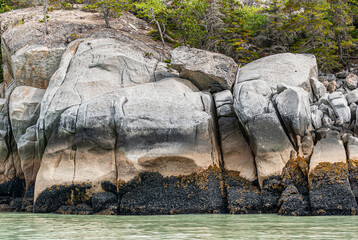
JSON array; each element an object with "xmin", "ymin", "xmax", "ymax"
[{"xmin": 119, "ymin": 168, "xmax": 226, "ymax": 215}]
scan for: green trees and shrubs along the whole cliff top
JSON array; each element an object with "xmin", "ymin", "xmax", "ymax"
[{"xmin": 0, "ymin": 0, "xmax": 358, "ymax": 71}]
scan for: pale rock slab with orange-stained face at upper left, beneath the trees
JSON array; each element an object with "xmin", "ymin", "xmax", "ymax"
[{"xmin": 0, "ymin": 6, "xmax": 167, "ymax": 92}]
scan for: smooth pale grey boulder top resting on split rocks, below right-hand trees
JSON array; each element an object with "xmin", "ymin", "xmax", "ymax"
[{"xmin": 238, "ymin": 53, "xmax": 318, "ymax": 92}]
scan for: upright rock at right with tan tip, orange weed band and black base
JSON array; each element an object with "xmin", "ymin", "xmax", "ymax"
[{"xmin": 308, "ymin": 132, "xmax": 357, "ymax": 215}]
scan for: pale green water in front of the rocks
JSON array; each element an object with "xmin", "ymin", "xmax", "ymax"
[{"xmin": 0, "ymin": 213, "xmax": 358, "ymax": 240}]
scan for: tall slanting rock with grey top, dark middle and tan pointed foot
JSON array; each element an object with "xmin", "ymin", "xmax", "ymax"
[{"xmin": 234, "ymin": 80, "xmax": 294, "ymax": 185}]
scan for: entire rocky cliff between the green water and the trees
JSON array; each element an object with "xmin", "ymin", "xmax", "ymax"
[{"xmin": 0, "ymin": 8, "xmax": 358, "ymax": 216}]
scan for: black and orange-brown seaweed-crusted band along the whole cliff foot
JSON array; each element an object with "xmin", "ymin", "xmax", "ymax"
[{"xmin": 4, "ymin": 161, "xmax": 358, "ymax": 216}]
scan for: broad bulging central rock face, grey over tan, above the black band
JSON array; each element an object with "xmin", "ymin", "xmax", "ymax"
[{"xmin": 35, "ymin": 78, "xmax": 220, "ymax": 209}]
